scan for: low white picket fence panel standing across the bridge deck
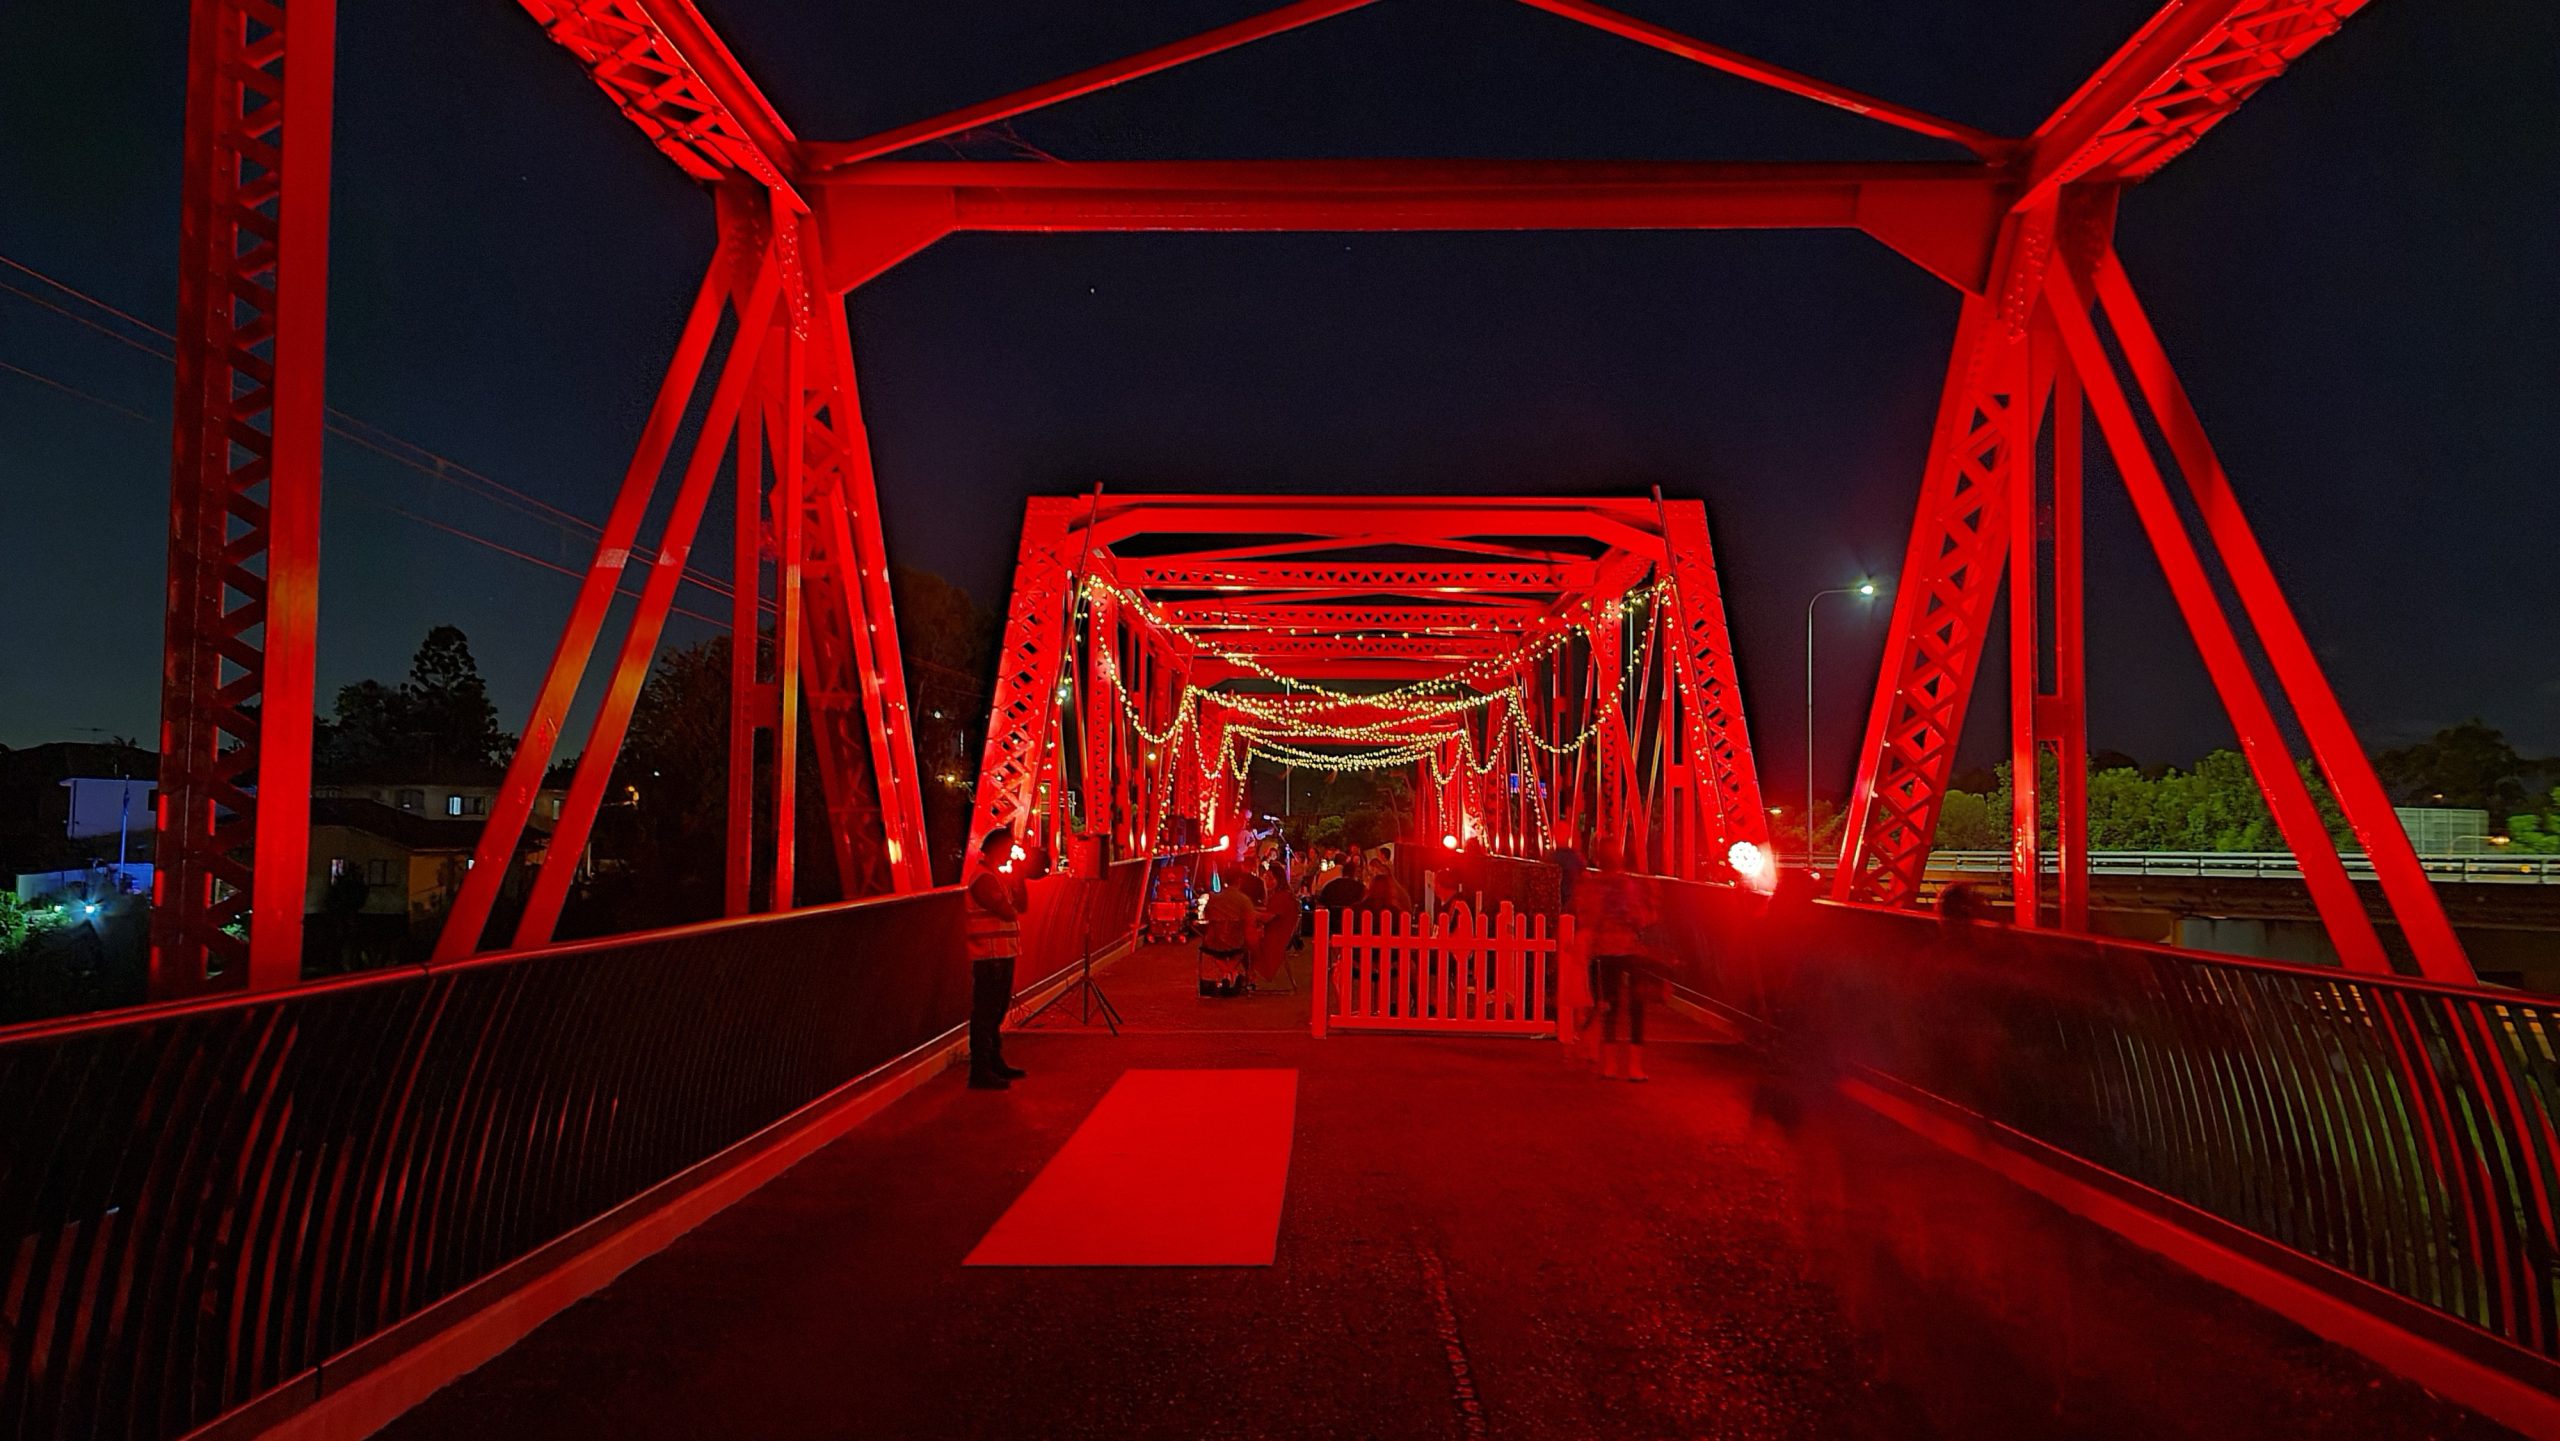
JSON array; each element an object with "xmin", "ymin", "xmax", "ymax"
[{"xmin": 1308, "ymin": 901, "xmax": 1574, "ymax": 1037}]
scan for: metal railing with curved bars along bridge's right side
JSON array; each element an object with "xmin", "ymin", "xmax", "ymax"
[{"xmin": 1628, "ymin": 880, "xmax": 2560, "ymax": 1387}]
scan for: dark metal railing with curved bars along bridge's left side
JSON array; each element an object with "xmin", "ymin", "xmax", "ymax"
[{"xmin": 0, "ymin": 863, "xmax": 1142, "ymax": 1441}]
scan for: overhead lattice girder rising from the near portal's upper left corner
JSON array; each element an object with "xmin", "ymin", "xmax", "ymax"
[{"xmin": 520, "ymin": 0, "xmax": 809, "ymax": 210}]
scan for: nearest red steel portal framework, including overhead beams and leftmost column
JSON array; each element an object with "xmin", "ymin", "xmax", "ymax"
[{"xmin": 154, "ymin": 0, "xmax": 2470, "ymax": 993}]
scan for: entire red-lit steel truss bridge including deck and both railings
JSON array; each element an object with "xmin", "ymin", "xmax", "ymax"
[{"xmin": 0, "ymin": 0, "xmax": 2560, "ymax": 1438}]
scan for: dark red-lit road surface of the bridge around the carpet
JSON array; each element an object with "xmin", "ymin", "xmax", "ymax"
[{"xmin": 389, "ymin": 952, "xmax": 2504, "ymax": 1441}]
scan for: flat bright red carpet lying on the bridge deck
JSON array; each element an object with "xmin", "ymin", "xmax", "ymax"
[{"xmin": 965, "ymin": 1070, "xmax": 1298, "ymax": 1267}]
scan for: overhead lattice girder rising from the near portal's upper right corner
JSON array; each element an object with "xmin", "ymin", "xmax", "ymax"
[{"xmin": 2017, "ymin": 0, "xmax": 2365, "ymax": 207}]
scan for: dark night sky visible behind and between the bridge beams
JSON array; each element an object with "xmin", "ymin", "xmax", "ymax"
[{"xmin": 0, "ymin": 0, "xmax": 2560, "ymax": 793}]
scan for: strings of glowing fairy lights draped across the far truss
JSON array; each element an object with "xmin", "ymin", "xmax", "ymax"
[{"xmin": 1078, "ymin": 576, "xmax": 1672, "ymax": 829}]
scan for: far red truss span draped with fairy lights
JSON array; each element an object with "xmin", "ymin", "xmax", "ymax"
[{"xmin": 970, "ymin": 491, "xmax": 1769, "ymax": 880}]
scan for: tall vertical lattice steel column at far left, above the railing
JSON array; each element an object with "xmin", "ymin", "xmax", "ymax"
[{"xmin": 151, "ymin": 0, "xmax": 338, "ymax": 996}]
